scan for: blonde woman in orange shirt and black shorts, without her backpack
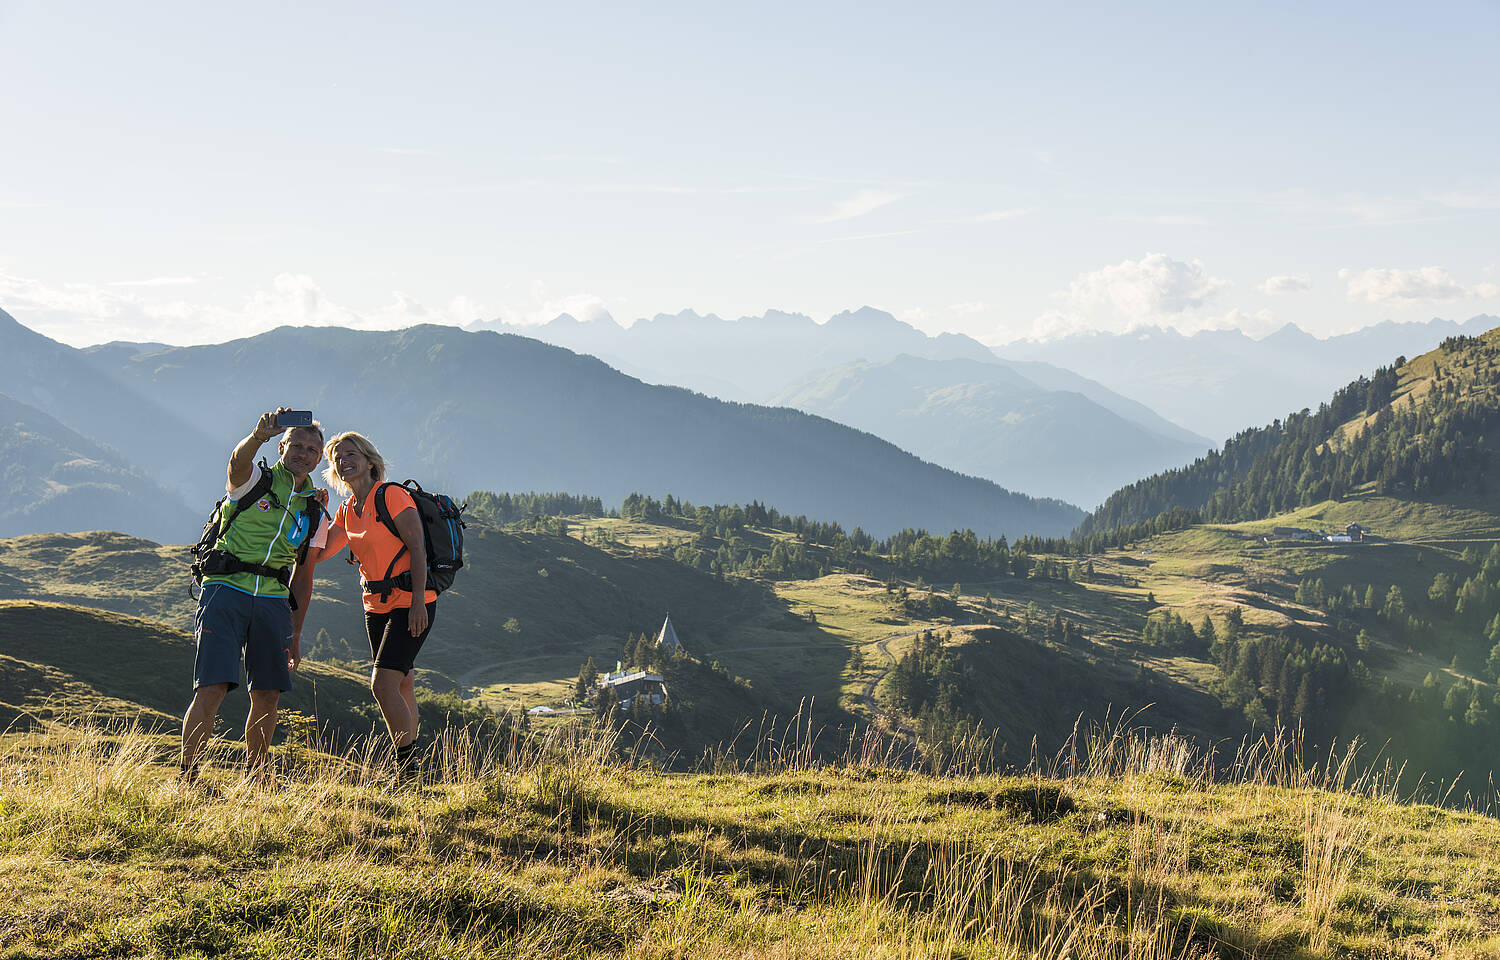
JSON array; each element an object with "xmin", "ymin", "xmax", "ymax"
[{"xmin": 315, "ymin": 432, "xmax": 438, "ymax": 767}]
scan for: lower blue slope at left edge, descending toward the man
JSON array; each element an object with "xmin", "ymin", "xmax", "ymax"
[{"xmin": 0, "ymin": 395, "xmax": 201, "ymax": 540}]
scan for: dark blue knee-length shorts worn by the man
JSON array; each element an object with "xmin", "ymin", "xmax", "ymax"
[{"xmin": 192, "ymin": 584, "xmax": 291, "ymax": 690}]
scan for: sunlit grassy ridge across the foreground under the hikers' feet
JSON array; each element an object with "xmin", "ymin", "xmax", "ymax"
[{"xmin": 0, "ymin": 723, "xmax": 1500, "ymax": 960}]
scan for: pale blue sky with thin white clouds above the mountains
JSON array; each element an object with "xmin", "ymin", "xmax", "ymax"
[{"xmin": 0, "ymin": 0, "xmax": 1500, "ymax": 345}]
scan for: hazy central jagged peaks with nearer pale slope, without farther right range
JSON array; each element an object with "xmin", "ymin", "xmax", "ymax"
[{"xmin": 470, "ymin": 306, "xmax": 1212, "ymax": 506}]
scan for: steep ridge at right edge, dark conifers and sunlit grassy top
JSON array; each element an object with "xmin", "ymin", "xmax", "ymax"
[{"xmin": 1074, "ymin": 332, "xmax": 1500, "ymax": 540}]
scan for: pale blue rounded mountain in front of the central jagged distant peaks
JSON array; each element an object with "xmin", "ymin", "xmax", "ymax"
[{"xmin": 776, "ymin": 354, "xmax": 1209, "ymax": 506}]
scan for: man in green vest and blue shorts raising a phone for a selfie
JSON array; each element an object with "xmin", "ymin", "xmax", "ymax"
[{"xmin": 182, "ymin": 407, "xmax": 327, "ymax": 779}]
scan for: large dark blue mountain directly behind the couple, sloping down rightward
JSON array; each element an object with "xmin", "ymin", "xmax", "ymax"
[{"xmin": 85, "ymin": 318, "xmax": 1082, "ymax": 536}]
